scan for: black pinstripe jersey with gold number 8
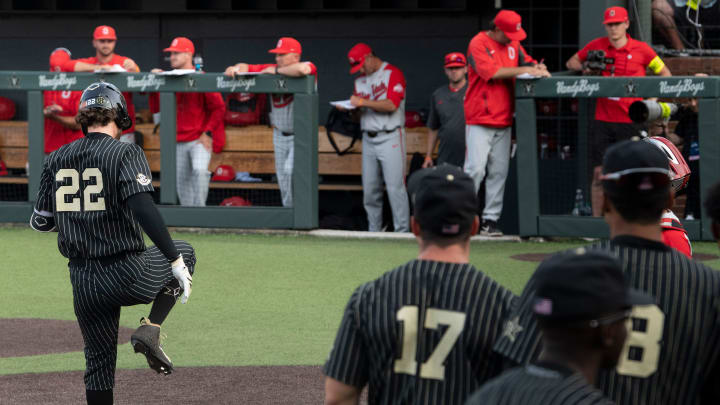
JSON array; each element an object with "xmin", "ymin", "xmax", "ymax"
[{"xmin": 495, "ymin": 236, "xmax": 720, "ymax": 405}]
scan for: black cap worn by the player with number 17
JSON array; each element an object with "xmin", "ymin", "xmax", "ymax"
[{"xmin": 408, "ymin": 164, "xmax": 478, "ymax": 236}]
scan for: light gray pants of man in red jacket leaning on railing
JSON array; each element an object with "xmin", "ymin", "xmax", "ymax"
[{"xmin": 463, "ymin": 125, "xmax": 511, "ymax": 221}]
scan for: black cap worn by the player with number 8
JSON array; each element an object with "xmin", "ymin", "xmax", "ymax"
[{"xmin": 600, "ymin": 137, "xmax": 673, "ymax": 192}]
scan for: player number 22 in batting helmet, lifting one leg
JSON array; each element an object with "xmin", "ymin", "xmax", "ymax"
[{"xmin": 30, "ymin": 83, "xmax": 195, "ymax": 404}]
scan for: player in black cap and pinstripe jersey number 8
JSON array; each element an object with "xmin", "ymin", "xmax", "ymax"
[{"xmin": 495, "ymin": 140, "xmax": 720, "ymax": 405}]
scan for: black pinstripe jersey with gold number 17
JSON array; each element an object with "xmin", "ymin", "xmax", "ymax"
[{"xmin": 324, "ymin": 260, "xmax": 515, "ymax": 404}]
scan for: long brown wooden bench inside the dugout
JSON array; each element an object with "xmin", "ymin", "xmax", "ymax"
[{"xmin": 0, "ymin": 121, "xmax": 427, "ymax": 190}]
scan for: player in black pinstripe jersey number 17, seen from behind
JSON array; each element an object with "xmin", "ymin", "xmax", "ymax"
[{"xmin": 324, "ymin": 165, "xmax": 515, "ymax": 404}]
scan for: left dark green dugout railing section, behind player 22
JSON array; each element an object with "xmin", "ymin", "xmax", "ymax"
[{"xmin": 0, "ymin": 71, "xmax": 318, "ymax": 229}]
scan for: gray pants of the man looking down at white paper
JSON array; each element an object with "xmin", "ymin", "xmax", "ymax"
[{"xmin": 362, "ymin": 128, "xmax": 410, "ymax": 232}]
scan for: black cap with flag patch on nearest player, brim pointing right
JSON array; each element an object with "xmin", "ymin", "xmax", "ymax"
[{"xmin": 533, "ymin": 248, "xmax": 655, "ymax": 322}]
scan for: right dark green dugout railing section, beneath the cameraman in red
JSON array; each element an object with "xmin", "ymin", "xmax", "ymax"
[{"xmin": 516, "ymin": 76, "xmax": 720, "ymax": 240}]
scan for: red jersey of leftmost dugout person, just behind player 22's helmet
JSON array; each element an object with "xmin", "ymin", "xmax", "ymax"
[{"xmin": 43, "ymin": 91, "xmax": 83, "ymax": 153}]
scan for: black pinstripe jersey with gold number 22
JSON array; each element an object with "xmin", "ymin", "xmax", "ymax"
[{"xmin": 35, "ymin": 133, "xmax": 153, "ymax": 258}]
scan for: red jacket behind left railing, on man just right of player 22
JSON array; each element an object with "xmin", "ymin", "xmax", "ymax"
[{"xmin": 150, "ymin": 93, "xmax": 225, "ymax": 153}]
